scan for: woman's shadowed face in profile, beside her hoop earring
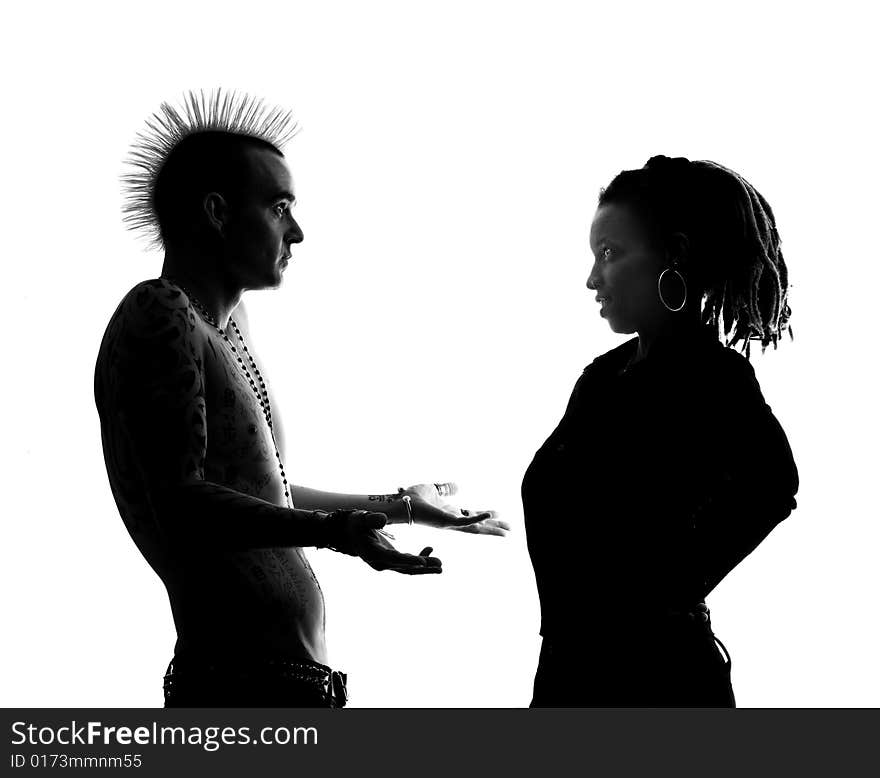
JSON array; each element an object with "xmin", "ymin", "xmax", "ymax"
[{"xmin": 587, "ymin": 203, "xmax": 665, "ymax": 333}]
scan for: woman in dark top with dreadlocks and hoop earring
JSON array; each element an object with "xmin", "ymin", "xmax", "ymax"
[{"xmin": 522, "ymin": 156, "xmax": 798, "ymax": 707}]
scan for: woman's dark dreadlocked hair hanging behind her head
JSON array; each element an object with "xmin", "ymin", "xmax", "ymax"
[{"xmin": 599, "ymin": 156, "xmax": 794, "ymax": 357}]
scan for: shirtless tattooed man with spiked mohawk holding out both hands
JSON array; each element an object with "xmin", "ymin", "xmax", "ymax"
[{"xmin": 95, "ymin": 90, "xmax": 508, "ymax": 707}]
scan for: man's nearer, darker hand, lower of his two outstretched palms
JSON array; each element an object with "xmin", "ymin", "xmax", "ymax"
[{"xmin": 325, "ymin": 511, "xmax": 443, "ymax": 575}]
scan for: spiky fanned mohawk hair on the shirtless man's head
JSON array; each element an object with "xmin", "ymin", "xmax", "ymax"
[{"xmin": 122, "ymin": 89, "xmax": 300, "ymax": 247}]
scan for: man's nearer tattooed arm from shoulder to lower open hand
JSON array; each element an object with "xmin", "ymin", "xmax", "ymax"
[{"xmin": 98, "ymin": 279, "xmax": 439, "ymax": 573}]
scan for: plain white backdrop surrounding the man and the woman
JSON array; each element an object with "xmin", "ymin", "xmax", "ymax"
[{"xmin": 0, "ymin": 0, "xmax": 880, "ymax": 707}]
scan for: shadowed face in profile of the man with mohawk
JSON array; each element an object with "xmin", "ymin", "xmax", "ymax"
[{"xmin": 224, "ymin": 148, "xmax": 303, "ymax": 289}]
